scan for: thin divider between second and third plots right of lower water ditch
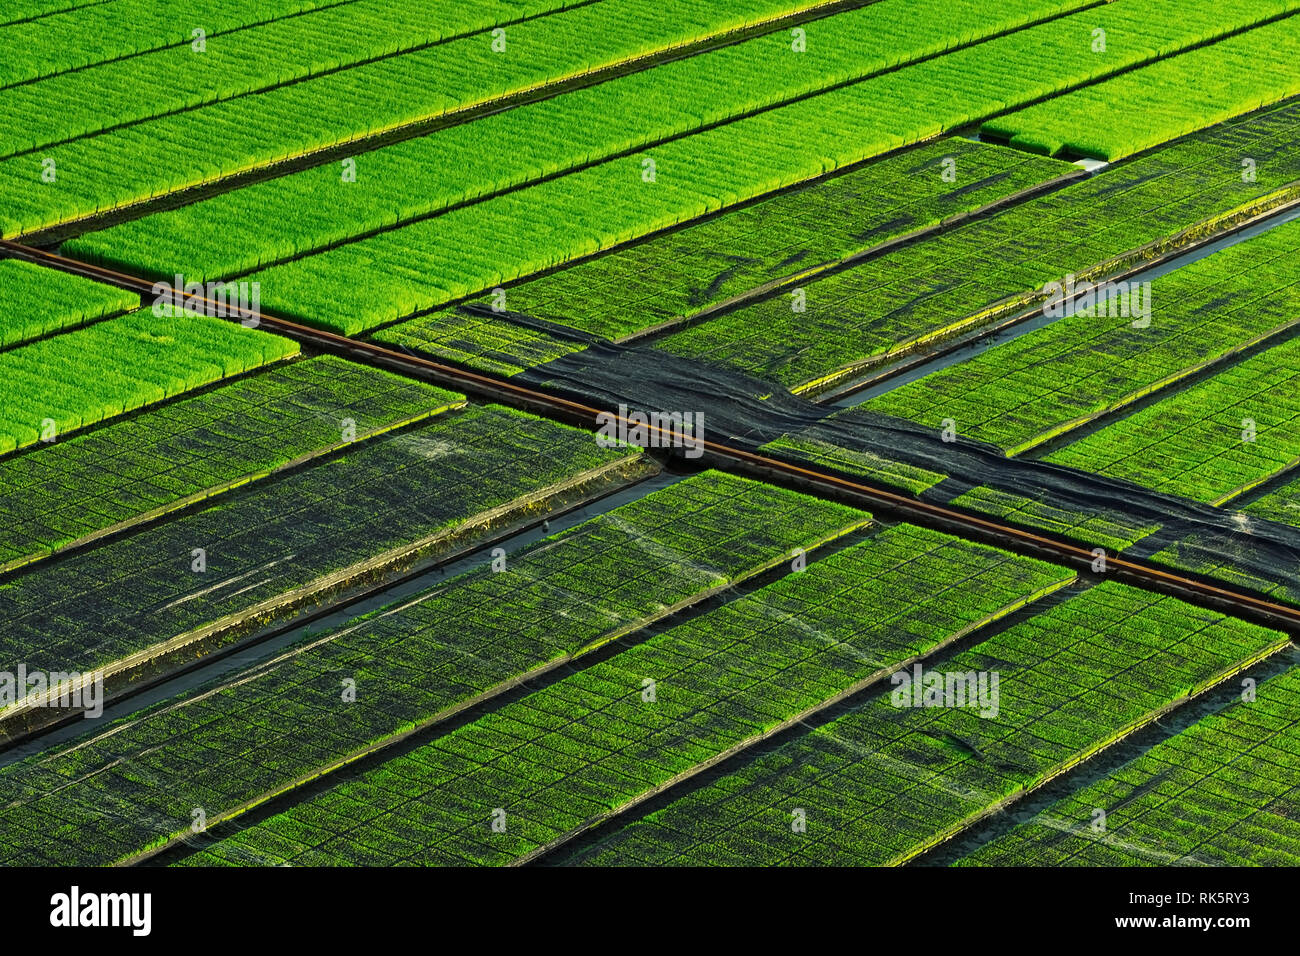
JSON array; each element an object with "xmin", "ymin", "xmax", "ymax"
[{"xmin": 511, "ymin": 575, "xmax": 1078, "ymax": 866}]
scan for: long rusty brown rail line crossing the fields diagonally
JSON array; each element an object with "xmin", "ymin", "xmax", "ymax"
[{"xmin": 0, "ymin": 239, "xmax": 1300, "ymax": 637}]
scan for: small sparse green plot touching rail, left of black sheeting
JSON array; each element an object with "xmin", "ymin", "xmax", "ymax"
[{"xmin": 374, "ymin": 310, "xmax": 588, "ymax": 376}]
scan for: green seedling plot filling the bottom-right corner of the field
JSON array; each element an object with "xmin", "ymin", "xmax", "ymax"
[{"xmin": 958, "ymin": 669, "xmax": 1300, "ymax": 866}]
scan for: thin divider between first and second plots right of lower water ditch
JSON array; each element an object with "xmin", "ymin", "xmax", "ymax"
[{"xmin": 122, "ymin": 515, "xmax": 875, "ymax": 865}]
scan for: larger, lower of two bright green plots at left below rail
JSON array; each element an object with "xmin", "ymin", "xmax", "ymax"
[{"xmin": 0, "ymin": 311, "xmax": 299, "ymax": 453}]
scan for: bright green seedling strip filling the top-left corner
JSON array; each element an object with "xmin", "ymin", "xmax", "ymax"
[{"xmin": 0, "ymin": 0, "xmax": 397, "ymax": 87}]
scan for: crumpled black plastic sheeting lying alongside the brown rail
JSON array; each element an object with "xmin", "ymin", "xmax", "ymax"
[{"xmin": 515, "ymin": 343, "xmax": 1300, "ymax": 593}]
